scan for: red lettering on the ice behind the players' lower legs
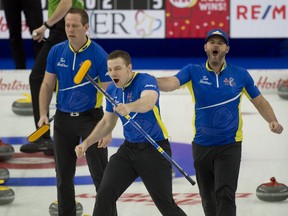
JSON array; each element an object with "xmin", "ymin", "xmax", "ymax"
[{"xmin": 76, "ymin": 193, "xmax": 252, "ymax": 205}]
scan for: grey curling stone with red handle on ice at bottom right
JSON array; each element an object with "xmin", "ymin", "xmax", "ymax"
[{"xmin": 256, "ymin": 177, "xmax": 288, "ymax": 202}]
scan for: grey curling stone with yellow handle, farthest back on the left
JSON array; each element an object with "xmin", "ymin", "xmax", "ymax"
[{"xmin": 12, "ymin": 94, "xmax": 33, "ymax": 116}]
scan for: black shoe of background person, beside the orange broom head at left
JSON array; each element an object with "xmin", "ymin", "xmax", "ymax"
[{"xmin": 20, "ymin": 138, "xmax": 54, "ymax": 155}]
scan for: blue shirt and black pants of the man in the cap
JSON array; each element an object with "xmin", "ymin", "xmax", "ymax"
[{"xmin": 176, "ymin": 61, "xmax": 260, "ymax": 216}]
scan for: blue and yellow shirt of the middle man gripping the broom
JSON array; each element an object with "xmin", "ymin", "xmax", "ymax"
[{"xmin": 106, "ymin": 73, "xmax": 168, "ymax": 143}]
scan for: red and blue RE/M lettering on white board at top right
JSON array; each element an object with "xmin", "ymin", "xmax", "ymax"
[{"xmin": 236, "ymin": 5, "xmax": 287, "ymax": 20}]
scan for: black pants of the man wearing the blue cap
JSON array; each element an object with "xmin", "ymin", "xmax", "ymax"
[{"xmin": 193, "ymin": 142, "xmax": 242, "ymax": 216}]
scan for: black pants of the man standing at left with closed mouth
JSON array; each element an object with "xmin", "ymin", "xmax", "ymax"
[{"xmin": 54, "ymin": 107, "xmax": 108, "ymax": 216}]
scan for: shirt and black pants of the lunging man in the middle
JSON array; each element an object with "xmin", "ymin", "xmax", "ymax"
[{"xmin": 95, "ymin": 73, "xmax": 186, "ymax": 216}]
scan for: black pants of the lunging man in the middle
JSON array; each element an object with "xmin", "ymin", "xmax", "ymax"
[{"xmin": 93, "ymin": 140, "xmax": 186, "ymax": 216}]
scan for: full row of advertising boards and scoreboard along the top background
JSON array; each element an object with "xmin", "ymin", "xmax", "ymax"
[{"xmin": 6, "ymin": 0, "xmax": 288, "ymax": 39}]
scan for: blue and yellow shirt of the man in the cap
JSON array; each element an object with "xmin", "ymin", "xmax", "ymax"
[{"xmin": 176, "ymin": 63, "xmax": 260, "ymax": 146}]
